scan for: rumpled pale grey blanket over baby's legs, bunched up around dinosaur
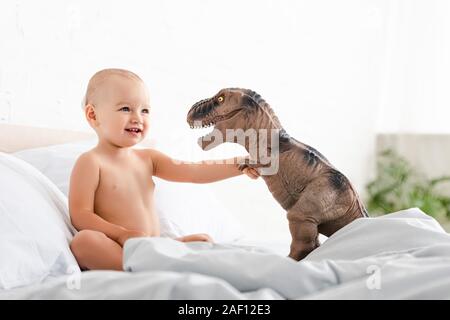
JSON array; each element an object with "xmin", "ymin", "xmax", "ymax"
[{"xmin": 124, "ymin": 209, "xmax": 450, "ymax": 299}]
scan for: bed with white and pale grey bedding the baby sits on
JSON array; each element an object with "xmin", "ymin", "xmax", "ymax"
[{"xmin": 0, "ymin": 125, "xmax": 450, "ymax": 299}]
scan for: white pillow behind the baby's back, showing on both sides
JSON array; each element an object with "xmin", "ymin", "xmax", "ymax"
[{"xmin": 14, "ymin": 141, "xmax": 243, "ymax": 242}]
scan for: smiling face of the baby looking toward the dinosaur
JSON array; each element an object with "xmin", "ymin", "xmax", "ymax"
[{"xmin": 93, "ymin": 76, "xmax": 150, "ymax": 147}]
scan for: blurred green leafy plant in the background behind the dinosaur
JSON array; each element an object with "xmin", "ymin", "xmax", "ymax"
[{"xmin": 367, "ymin": 150, "xmax": 450, "ymax": 222}]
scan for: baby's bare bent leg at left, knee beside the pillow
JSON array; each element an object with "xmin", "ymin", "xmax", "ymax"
[{"xmin": 70, "ymin": 230, "xmax": 123, "ymax": 271}]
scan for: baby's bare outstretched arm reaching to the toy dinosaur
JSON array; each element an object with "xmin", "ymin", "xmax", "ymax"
[{"xmin": 149, "ymin": 150, "xmax": 259, "ymax": 183}]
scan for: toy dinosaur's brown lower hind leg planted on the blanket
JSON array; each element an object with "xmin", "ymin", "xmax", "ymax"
[{"xmin": 288, "ymin": 214, "xmax": 320, "ymax": 261}]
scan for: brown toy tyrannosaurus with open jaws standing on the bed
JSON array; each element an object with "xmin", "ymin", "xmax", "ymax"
[{"xmin": 187, "ymin": 88, "xmax": 368, "ymax": 260}]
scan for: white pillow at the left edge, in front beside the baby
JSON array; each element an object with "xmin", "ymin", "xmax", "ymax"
[{"xmin": 0, "ymin": 153, "xmax": 79, "ymax": 289}]
